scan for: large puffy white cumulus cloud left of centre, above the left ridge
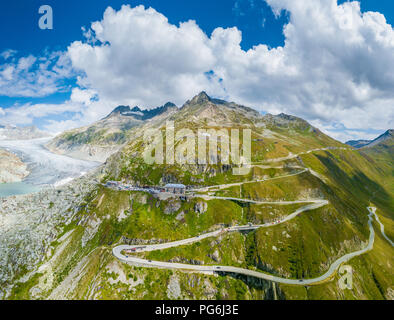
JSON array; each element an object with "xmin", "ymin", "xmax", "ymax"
[{"xmin": 68, "ymin": 6, "xmax": 222, "ymax": 106}]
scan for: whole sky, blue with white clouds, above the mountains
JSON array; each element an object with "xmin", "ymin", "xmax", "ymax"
[{"xmin": 0, "ymin": 0, "xmax": 394, "ymax": 141}]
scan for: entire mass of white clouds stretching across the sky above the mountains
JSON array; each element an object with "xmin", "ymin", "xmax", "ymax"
[{"xmin": 0, "ymin": 0, "xmax": 394, "ymax": 140}]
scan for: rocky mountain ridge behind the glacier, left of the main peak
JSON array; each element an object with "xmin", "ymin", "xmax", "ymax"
[{"xmin": 46, "ymin": 102, "xmax": 178, "ymax": 162}]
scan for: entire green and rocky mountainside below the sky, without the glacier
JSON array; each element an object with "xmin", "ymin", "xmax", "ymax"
[{"xmin": 0, "ymin": 92, "xmax": 394, "ymax": 300}]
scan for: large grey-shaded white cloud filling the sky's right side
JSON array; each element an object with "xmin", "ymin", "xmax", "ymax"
[{"xmin": 212, "ymin": 0, "xmax": 394, "ymax": 129}]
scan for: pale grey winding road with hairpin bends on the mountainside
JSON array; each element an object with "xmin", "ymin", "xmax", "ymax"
[{"xmin": 112, "ymin": 148, "xmax": 393, "ymax": 286}]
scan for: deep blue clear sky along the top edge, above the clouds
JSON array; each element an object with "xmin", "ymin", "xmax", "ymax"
[{"xmin": 0, "ymin": 0, "xmax": 394, "ymax": 54}]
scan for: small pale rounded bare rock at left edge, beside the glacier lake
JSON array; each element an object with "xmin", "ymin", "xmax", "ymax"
[{"xmin": 0, "ymin": 149, "xmax": 30, "ymax": 183}]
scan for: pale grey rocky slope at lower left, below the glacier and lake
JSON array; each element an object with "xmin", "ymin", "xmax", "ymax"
[{"xmin": 0, "ymin": 175, "xmax": 97, "ymax": 299}]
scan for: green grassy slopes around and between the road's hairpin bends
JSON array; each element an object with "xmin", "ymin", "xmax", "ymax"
[{"xmin": 7, "ymin": 117, "xmax": 394, "ymax": 299}]
